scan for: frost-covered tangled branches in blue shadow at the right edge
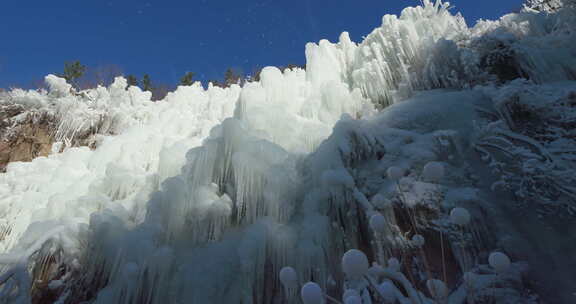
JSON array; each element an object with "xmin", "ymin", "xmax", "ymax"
[{"xmin": 476, "ymin": 82, "xmax": 576, "ymax": 214}]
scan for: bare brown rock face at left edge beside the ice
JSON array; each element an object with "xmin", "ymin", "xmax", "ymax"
[{"xmin": 0, "ymin": 105, "xmax": 54, "ymax": 172}]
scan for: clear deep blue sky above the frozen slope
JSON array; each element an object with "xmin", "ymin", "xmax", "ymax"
[{"xmin": 0, "ymin": 0, "xmax": 522, "ymax": 87}]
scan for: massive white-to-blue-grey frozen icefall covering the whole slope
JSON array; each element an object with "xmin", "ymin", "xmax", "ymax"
[{"xmin": 0, "ymin": 1, "xmax": 576, "ymax": 304}]
